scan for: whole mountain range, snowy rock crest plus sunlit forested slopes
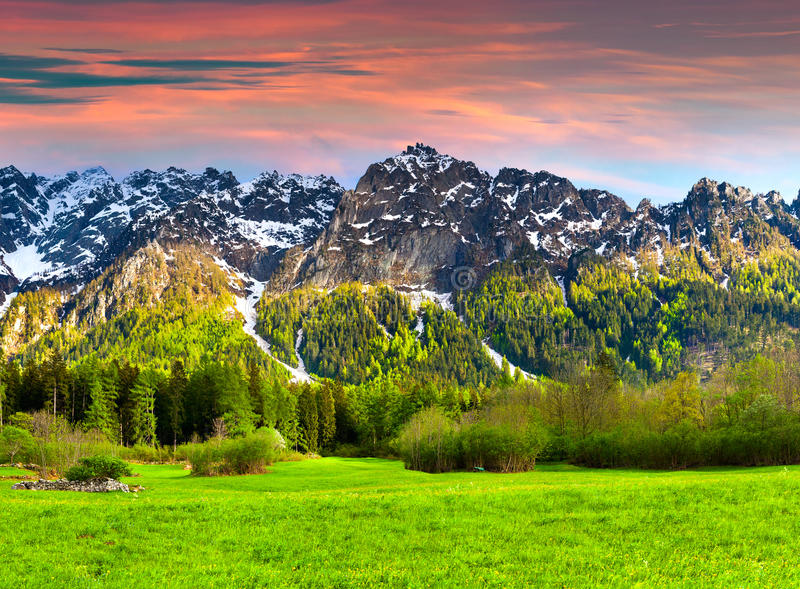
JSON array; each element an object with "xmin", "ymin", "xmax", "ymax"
[{"xmin": 0, "ymin": 144, "xmax": 800, "ymax": 386}]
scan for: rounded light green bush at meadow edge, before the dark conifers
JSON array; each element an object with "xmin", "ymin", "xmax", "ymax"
[{"xmin": 180, "ymin": 428, "xmax": 286, "ymax": 476}]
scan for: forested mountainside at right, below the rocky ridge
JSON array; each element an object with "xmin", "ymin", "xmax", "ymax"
[{"xmin": 456, "ymin": 248, "xmax": 800, "ymax": 382}]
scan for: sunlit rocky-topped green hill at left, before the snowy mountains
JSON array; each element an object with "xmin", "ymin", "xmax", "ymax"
[{"xmin": 14, "ymin": 247, "xmax": 285, "ymax": 377}]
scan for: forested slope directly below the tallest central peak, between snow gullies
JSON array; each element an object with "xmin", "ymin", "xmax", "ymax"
[{"xmin": 258, "ymin": 283, "xmax": 499, "ymax": 387}]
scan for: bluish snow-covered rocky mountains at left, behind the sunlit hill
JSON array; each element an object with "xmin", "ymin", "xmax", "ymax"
[{"xmin": 0, "ymin": 166, "xmax": 344, "ymax": 292}]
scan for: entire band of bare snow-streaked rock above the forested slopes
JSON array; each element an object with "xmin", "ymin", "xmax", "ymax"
[{"xmin": 0, "ymin": 143, "xmax": 800, "ymax": 293}]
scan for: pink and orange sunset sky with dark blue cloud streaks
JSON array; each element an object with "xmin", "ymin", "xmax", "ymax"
[{"xmin": 0, "ymin": 0, "xmax": 800, "ymax": 205}]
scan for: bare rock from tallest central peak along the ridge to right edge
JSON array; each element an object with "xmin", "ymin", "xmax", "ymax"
[{"xmin": 271, "ymin": 144, "xmax": 800, "ymax": 290}]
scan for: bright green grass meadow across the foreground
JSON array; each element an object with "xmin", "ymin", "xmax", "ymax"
[{"xmin": 0, "ymin": 458, "xmax": 800, "ymax": 587}]
